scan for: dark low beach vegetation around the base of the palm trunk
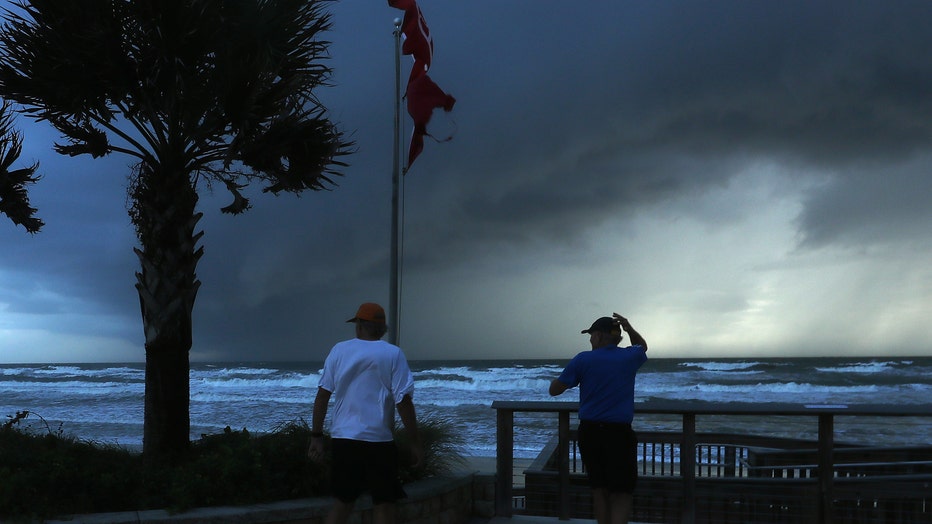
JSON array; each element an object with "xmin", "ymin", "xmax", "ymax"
[{"xmin": 0, "ymin": 412, "xmax": 464, "ymax": 522}]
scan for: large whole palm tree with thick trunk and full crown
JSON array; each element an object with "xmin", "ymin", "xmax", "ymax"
[{"xmin": 0, "ymin": 0, "xmax": 352, "ymax": 457}]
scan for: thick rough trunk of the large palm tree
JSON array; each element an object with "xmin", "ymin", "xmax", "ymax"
[{"xmin": 131, "ymin": 164, "xmax": 203, "ymax": 458}]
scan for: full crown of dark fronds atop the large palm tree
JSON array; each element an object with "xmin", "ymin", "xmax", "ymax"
[{"xmin": 0, "ymin": 0, "xmax": 353, "ymax": 212}]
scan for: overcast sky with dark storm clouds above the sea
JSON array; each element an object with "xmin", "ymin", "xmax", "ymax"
[{"xmin": 0, "ymin": 0, "xmax": 932, "ymax": 363}]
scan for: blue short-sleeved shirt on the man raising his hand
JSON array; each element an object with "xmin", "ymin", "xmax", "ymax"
[{"xmin": 558, "ymin": 346, "xmax": 647, "ymax": 424}]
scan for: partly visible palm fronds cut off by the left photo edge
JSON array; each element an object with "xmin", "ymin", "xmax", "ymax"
[{"xmin": 0, "ymin": 100, "xmax": 44, "ymax": 233}]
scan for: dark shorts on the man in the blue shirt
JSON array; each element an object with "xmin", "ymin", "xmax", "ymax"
[{"xmin": 579, "ymin": 420, "xmax": 638, "ymax": 493}]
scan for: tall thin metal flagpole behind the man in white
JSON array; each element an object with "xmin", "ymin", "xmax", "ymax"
[{"xmin": 388, "ymin": 18, "xmax": 401, "ymax": 345}]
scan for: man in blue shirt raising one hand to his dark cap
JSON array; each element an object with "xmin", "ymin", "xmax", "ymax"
[{"xmin": 550, "ymin": 313, "xmax": 647, "ymax": 524}]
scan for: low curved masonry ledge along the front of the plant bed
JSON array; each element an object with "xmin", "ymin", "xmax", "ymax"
[{"xmin": 46, "ymin": 472, "xmax": 494, "ymax": 524}]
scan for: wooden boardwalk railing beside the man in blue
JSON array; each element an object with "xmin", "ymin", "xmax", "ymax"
[{"xmin": 492, "ymin": 401, "xmax": 932, "ymax": 524}]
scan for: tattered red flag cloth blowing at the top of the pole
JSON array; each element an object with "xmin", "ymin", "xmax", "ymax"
[{"xmin": 388, "ymin": 0, "xmax": 456, "ymax": 168}]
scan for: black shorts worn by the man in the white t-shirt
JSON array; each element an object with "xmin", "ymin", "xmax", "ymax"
[{"xmin": 331, "ymin": 439, "xmax": 406, "ymax": 504}]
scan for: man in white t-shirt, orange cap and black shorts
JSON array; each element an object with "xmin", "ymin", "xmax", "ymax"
[{"xmin": 308, "ymin": 302, "xmax": 423, "ymax": 524}]
